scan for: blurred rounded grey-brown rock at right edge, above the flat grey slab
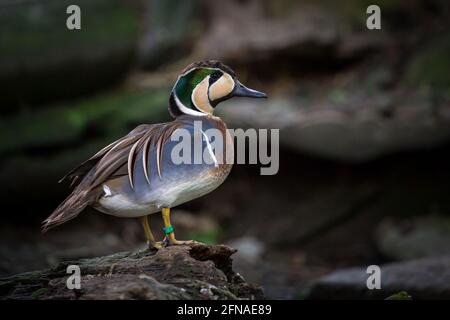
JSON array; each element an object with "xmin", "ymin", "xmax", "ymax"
[{"xmin": 376, "ymin": 215, "xmax": 450, "ymax": 260}]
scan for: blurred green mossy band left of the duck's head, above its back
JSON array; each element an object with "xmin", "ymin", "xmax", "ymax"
[{"xmin": 0, "ymin": 89, "xmax": 168, "ymax": 153}]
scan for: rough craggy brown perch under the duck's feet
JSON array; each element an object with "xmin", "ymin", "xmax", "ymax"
[{"xmin": 0, "ymin": 245, "xmax": 263, "ymax": 300}]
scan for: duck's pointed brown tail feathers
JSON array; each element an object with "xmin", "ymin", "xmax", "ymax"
[{"xmin": 42, "ymin": 189, "xmax": 89, "ymax": 232}]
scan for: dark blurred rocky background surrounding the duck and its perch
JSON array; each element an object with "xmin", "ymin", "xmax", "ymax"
[{"xmin": 0, "ymin": 0, "xmax": 450, "ymax": 299}]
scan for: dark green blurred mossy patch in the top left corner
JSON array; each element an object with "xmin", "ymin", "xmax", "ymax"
[{"xmin": 0, "ymin": 0, "xmax": 138, "ymax": 58}]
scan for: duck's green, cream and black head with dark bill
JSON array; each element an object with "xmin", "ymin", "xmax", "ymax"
[{"xmin": 169, "ymin": 60, "xmax": 267, "ymax": 117}]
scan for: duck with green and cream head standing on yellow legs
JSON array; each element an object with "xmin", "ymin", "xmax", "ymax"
[{"xmin": 42, "ymin": 60, "xmax": 267, "ymax": 250}]
